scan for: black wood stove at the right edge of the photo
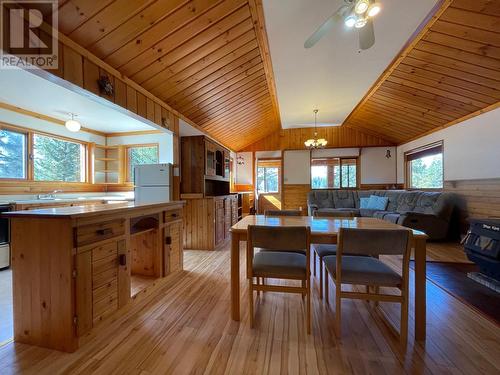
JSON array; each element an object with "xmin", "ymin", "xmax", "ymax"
[{"xmin": 464, "ymin": 219, "xmax": 500, "ymax": 289}]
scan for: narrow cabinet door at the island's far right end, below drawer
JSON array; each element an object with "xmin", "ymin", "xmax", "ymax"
[{"xmin": 163, "ymin": 221, "xmax": 184, "ymax": 276}]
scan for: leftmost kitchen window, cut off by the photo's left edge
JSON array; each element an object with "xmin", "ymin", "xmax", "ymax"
[{"xmin": 0, "ymin": 129, "xmax": 27, "ymax": 179}]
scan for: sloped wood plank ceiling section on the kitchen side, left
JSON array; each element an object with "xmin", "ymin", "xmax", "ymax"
[{"xmin": 55, "ymin": 0, "xmax": 280, "ymax": 150}]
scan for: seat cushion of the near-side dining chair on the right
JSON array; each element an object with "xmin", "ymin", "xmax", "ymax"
[{"xmin": 323, "ymin": 255, "xmax": 402, "ymax": 287}]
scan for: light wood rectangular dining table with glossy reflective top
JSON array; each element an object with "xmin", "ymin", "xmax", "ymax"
[{"xmin": 230, "ymin": 215, "xmax": 427, "ymax": 341}]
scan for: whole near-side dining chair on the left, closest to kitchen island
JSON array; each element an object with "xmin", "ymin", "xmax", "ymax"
[{"xmin": 246, "ymin": 225, "xmax": 311, "ymax": 333}]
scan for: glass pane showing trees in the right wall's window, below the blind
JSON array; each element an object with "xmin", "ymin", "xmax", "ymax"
[{"xmin": 410, "ymin": 153, "xmax": 443, "ymax": 189}]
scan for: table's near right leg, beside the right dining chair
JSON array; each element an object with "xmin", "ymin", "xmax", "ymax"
[{"xmin": 415, "ymin": 238, "xmax": 427, "ymax": 341}]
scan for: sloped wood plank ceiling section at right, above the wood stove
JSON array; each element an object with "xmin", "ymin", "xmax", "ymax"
[{"xmin": 344, "ymin": 0, "xmax": 500, "ymax": 144}]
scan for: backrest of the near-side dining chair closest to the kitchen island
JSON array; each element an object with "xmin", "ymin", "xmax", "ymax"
[{"xmin": 248, "ymin": 225, "xmax": 310, "ymax": 251}]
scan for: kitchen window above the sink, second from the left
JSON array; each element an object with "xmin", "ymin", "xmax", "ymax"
[{"xmin": 33, "ymin": 133, "xmax": 85, "ymax": 182}]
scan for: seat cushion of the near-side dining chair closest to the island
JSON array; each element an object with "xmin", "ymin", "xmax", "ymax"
[{"xmin": 253, "ymin": 251, "xmax": 307, "ymax": 279}]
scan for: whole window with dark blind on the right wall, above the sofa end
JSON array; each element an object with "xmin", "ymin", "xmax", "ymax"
[{"xmin": 405, "ymin": 142, "xmax": 443, "ymax": 189}]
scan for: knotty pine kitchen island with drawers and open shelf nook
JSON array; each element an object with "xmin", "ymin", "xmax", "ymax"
[{"xmin": 4, "ymin": 201, "xmax": 184, "ymax": 352}]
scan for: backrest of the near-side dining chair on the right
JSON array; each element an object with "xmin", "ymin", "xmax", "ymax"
[{"xmin": 339, "ymin": 228, "xmax": 411, "ymax": 255}]
